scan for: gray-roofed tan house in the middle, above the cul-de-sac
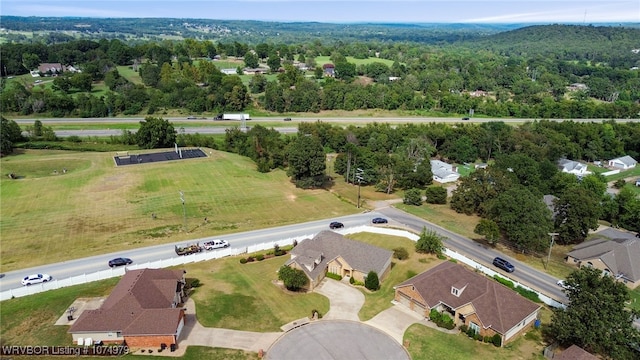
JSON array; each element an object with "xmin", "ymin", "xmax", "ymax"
[{"xmin": 285, "ymin": 230, "xmax": 393, "ymax": 290}]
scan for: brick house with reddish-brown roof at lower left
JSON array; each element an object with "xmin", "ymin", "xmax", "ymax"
[{"xmin": 68, "ymin": 269, "xmax": 185, "ymax": 347}]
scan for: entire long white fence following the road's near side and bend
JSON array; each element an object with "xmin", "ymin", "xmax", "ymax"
[{"xmin": 0, "ymin": 225, "xmax": 565, "ymax": 307}]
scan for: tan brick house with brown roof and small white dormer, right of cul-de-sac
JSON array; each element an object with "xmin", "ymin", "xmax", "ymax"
[{"xmin": 395, "ymin": 261, "xmax": 540, "ymax": 345}]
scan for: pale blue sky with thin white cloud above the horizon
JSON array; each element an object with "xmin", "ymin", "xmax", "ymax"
[{"xmin": 0, "ymin": 0, "xmax": 640, "ymax": 26}]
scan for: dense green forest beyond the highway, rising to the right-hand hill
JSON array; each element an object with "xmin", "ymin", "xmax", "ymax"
[{"xmin": 0, "ymin": 25, "xmax": 640, "ymax": 119}]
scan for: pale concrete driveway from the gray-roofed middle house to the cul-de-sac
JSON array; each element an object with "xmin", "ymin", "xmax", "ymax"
[{"xmin": 314, "ymin": 278, "xmax": 364, "ymax": 321}]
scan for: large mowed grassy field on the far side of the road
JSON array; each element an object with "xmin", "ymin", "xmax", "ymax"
[{"xmin": 0, "ymin": 150, "xmax": 356, "ymax": 272}]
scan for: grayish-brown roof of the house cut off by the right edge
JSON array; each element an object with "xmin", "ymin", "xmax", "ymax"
[{"xmin": 567, "ymin": 238, "xmax": 640, "ymax": 282}]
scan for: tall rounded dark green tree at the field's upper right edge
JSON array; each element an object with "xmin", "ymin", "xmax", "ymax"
[{"xmin": 287, "ymin": 134, "xmax": 326, "ymax": 188}]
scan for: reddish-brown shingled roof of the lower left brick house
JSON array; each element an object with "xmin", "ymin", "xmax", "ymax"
[{"xmin": 69, "ymin": 269, "xmax": 184, "ymax": 335}]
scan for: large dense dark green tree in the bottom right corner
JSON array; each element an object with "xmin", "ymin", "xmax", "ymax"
[{"xmin": 548, "ymin": 267, "xmax": 640, "ymax": 360}]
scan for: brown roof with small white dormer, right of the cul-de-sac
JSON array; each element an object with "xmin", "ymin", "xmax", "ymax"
[{"xmin": 397, "ymin": 261, "xmax": 540, "ymax": 334}]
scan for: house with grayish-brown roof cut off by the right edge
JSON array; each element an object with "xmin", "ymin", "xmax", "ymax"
[{"xmin": 566, "ymin": 235, "xmax": 640, "ymax": 289}]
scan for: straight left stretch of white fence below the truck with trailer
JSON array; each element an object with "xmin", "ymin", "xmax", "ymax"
[{"xmin": 0, "ymin": 234, "xmax": 315, "ymax": 301}]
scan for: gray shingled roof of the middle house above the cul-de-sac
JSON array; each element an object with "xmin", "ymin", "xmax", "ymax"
[{"xmin": 287, "ymin": 230, "xmax": 393, "ymax": 279}]
